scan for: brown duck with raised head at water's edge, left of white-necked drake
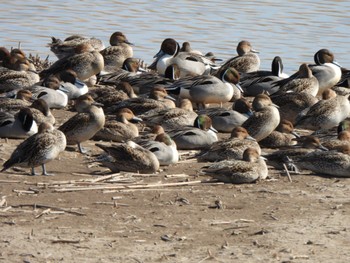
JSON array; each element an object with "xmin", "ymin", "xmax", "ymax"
[{"xmin": 101, "ymin": 32, "xmax": 134, "ymax": 74}]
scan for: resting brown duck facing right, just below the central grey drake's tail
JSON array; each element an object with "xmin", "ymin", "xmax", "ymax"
[{"xmin": 105, "ymin": 86, "xmax": 176, "ymax": 115}]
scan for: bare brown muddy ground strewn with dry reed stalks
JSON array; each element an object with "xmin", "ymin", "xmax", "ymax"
[{"xmin": 0, "ymin": 110, "xmax": 350, "ymax": 263}]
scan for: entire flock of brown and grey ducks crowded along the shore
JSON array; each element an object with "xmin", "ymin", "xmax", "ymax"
[{"xmin": 0, "ymin": 32, "xmax": 350, "ymax": 179}]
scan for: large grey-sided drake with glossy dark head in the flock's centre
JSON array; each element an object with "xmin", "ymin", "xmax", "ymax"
[{"xmin": 167, "ymin": 68, "xmax": 241, "ymax": 108}]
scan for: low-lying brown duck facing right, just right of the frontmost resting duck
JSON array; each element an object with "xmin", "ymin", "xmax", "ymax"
[{"xmin": 264, "ymin": 136, "xmax": 328, "ymax": 172}]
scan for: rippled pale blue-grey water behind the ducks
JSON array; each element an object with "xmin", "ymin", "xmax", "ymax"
[{"xmin": 0, "ymin": 0, "xmax": 350, "ymax": 74}]
